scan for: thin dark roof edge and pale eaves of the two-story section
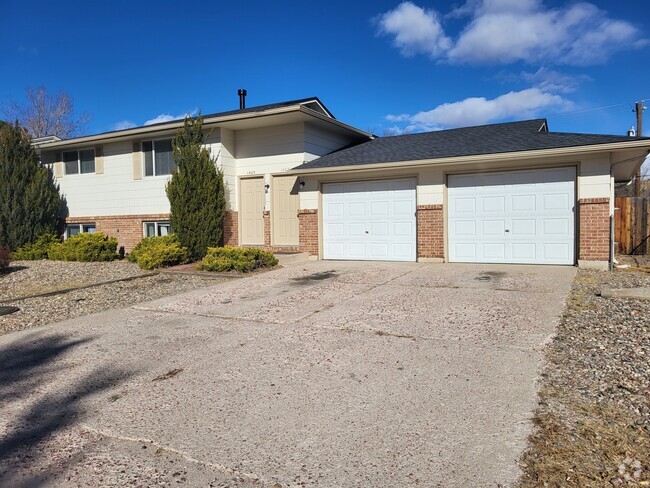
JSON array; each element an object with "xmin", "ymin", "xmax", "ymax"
[{"xmin": 32, "ymin": 97, "xmax": 364, "ymax": 149}]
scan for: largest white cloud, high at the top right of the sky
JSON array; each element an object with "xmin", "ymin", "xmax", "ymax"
[{"xmin": 379, "ymin": 0, "xmax": 648, "ymax": 66}]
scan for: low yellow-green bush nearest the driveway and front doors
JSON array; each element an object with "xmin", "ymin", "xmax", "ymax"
[{"xmin": 196, "ymin": 246, "xmax": 278, "ymax": 273}]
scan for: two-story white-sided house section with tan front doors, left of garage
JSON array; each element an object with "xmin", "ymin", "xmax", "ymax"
[{"xmin": 36, "ymin": 97, "xmax": 371, "ymax": 252}]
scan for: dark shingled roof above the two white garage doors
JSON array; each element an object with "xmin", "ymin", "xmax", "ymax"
[{"xmin": 295, "ymin": 119, "xmax": 650, "ymax": 171}]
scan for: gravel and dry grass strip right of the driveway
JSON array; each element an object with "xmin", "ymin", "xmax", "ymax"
[{"xmin": 520, "ymin": 264, "xmax": 650, "ymax": 487}]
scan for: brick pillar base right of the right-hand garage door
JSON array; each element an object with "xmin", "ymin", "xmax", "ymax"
[{"xmin": 578, "ymin": 198, "xmax": 610, "ymax": 261}]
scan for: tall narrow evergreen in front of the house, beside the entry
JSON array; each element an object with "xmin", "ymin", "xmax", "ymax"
[{"xmin": 167, "ymin": 114, "xmax": 226, "ymax": 260}]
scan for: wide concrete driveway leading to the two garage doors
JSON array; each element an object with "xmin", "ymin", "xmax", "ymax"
[{"xmin": 0, "ymin": 262, "xmax": 575, "ymax": 487}]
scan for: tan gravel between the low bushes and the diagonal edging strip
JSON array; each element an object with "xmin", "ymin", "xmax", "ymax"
[{"xmin": 0, "ymin": 260, "xmax": 145, "ymax": 300}]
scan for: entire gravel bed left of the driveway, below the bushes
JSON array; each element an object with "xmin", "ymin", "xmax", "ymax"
[{"xmin": 0, "ymin": 261, "xmax": 227, "ymax": 334}]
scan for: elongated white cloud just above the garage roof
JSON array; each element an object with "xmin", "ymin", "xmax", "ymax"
[{"xmin": 386, "ymin": 88, "xmax": 573, "ymax": 132}]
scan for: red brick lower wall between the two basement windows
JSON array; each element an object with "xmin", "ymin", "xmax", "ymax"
[{"xmin": 66, "ymin": 214, "xmax": 169, "ymax": 252}]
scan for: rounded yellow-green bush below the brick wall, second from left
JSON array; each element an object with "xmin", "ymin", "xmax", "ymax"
[{"xmin": 47, "ymin": 232, "xmax": 118, "ymax": 261}]
